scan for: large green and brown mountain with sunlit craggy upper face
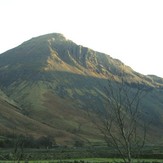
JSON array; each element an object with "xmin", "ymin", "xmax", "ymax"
[{"xmin": 0, "ymin": 33, "xmax": 163, "ymax": 144}]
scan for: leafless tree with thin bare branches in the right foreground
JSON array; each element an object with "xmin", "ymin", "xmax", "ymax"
[{"xmin": 90, "ymin": 77, "xmax": 147, "ymax": 163}]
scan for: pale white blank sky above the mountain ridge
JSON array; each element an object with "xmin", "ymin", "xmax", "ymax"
[{"xmin": 0, "ymin": 0, "xmax": 163, "ymax": 77}]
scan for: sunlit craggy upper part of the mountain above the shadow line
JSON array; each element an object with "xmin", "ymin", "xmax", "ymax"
[{"xmin": 0, "ymin": 33, "xmax": 162, "ymax": 84}]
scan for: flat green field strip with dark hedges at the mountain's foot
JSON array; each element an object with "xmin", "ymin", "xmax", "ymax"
[{"xmin": 0, "ymin": 146, "xmax": 163, "ymax": 163}]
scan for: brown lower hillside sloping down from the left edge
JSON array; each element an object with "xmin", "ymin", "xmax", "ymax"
[{"xmin": 0, "ymin": 95, "xmax": 81, "ymax": 143}]
